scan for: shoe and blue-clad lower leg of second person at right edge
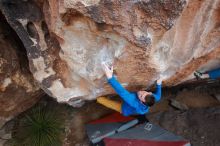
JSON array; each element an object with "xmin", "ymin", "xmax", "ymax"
[{"xmin": 194, "ymin": 68, "xmax": 220, "ymax": 79}]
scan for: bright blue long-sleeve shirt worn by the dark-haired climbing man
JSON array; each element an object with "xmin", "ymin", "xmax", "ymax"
[{"xmin": 108, "ymin": 76, "xmax": 161, "ymax": 116}]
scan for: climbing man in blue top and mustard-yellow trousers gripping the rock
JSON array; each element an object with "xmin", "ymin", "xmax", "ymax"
[{"xmin": 97, "ymin": 63, "xmax": 162, "ymax": 116}]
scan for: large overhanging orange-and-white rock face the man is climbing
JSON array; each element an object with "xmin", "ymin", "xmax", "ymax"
[{"xmin": 0, "ymin": 0, "xmax": 220, "ymax": 105}]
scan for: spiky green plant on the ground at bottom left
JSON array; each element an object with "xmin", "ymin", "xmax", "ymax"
[{"xmin": 13, "ymin": 106, "xmax": 64, "ymax": 146}]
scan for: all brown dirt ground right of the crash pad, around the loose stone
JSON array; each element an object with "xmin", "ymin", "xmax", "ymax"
[{"xmin": 147, "ymin": 82, "xmax": 220, "ymax": 146}]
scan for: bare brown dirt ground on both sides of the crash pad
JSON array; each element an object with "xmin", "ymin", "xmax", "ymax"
[{"xmin": 2, "ymin": 80, "xmax": 220, "ymax": 146}]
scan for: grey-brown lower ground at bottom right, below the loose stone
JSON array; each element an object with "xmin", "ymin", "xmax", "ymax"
[{"xmin": 148, "ymin": 106, "xmax": 220, "ymax": 146}]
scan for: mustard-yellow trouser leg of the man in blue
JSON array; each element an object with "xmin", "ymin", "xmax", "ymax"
[{"xmin": 97, "ymin": 97, "xmax": 122, "ymax": 113}]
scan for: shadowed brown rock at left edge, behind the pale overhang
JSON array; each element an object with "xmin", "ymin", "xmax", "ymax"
[{"xmin": 0, "ymin": 14, "xmax": 42, "ymax": 128}]
